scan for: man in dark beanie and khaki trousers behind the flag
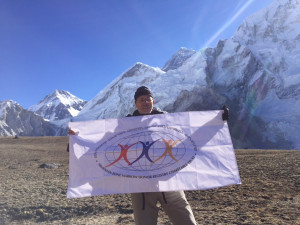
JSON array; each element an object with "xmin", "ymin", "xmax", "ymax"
[{"xmin": 128, "ymin": 86, "xmax": 197, "ymax": 225}]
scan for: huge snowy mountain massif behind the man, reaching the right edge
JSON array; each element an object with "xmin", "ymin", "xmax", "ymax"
[{"xmin": 75, "ymin": 0, "xmax": 300, "ymax": 149}]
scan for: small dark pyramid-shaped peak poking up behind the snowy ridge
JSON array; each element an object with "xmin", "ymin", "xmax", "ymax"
[{"xmin": 162, "ymin": 47, "xmax": 196, "ymax": 72}]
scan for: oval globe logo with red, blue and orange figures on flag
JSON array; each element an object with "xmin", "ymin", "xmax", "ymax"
[{"xmin": 94, "ymin": 125, "xmax": 197, "ymax": 178}]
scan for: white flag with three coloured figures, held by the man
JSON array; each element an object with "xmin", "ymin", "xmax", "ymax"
[{"xmin": 67, "ymin": 111, "xmax": 241, "ymax": 198}]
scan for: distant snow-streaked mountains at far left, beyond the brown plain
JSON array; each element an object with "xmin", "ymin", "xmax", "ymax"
[{"xmin": 0, "ymin": 90, "xmax": 86, "ymax": 136}]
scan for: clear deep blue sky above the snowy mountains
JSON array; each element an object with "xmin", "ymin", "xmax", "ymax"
[{"xmin": 0, "ymin": 0, "xmax": 272, "ymax": 108}]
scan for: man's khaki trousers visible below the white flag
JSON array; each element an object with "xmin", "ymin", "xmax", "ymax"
[{"xmin": 131, "ymin": 191, "xmax": 197, "ymax": 225}]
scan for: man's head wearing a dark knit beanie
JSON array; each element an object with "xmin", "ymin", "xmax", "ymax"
[{"xmin": 134, "ymin": 86, "xmax": 154, "ymax": 115}]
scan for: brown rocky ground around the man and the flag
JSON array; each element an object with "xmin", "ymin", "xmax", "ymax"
[{"xmin": 0, "ymin": 137, "xmax": 300, "ymax": 225}]
